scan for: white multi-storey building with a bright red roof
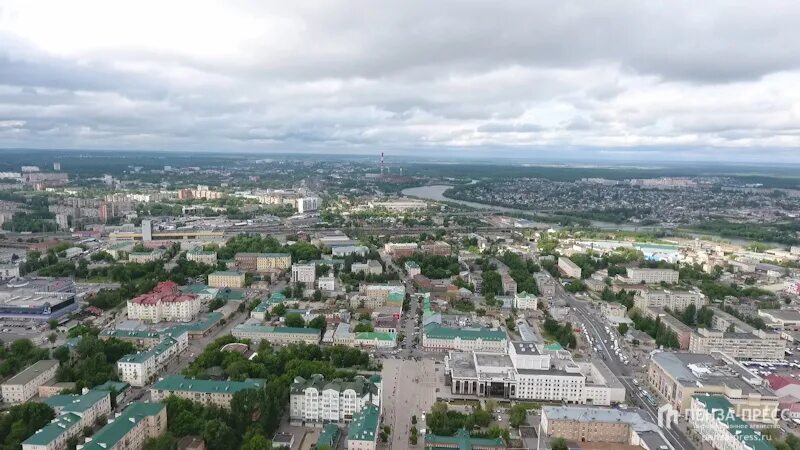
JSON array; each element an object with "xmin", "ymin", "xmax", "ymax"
[{"xmin": 128, "ymin": 281, "xmax": 201, "ymax": 323}]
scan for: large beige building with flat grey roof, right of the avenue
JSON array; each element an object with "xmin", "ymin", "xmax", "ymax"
[{"xmin": 647, "ymin": 352, "xmax": 778, "ymax": 423}]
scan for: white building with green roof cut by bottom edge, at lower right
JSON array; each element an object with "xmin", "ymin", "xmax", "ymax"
[{"xmin": 688, "ymin": 395, "xmax": 775, "ymax": 450}]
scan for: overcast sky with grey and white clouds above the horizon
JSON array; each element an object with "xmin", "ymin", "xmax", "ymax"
[{"xmin": 0, "ymin": 0, "xmax": 800, "ymax": 161}]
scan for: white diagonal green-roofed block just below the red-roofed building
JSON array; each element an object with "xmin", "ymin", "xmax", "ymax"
[{"xmin": 117, "ymin": 329, "xmax": 189, "ymax": 387}]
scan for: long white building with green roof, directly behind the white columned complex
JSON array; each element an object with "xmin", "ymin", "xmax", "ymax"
[{"xmin": 422, "ymin": 323, "xmax": 508, "ymax": 353}]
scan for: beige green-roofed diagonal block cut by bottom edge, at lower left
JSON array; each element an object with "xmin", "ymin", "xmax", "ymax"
[{"xmin": 81, "ymin": 402, "xmax": 167, "ymax": 450}]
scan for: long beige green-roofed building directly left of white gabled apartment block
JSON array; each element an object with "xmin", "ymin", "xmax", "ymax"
[{"xmin": 150, "ymin": 375, "xmax": 265, "ymax": 409}]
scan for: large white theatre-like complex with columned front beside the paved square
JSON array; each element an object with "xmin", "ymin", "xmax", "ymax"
[{"xmin": 444, "ymin": 342, "xmax": 625, "ymax": 406}]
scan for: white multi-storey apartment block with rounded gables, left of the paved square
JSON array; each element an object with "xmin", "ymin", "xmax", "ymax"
[{"xmin": 289, "ymin": 374, "xmax": 383, "ymax": 426}]
